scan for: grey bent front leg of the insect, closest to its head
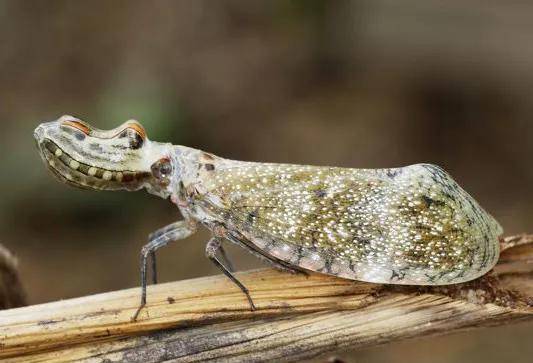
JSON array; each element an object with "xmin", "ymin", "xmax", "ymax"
[{"xmin": 132, "ymin": 220, "xmax": 196, "ymax": 321}]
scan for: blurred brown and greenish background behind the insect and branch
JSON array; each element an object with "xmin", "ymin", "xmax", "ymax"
[{"xmin": 0, "ymin": 0, "xmax": 533, "ymax": 363}]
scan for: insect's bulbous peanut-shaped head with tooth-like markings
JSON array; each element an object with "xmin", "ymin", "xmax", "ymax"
[{"xmin": 34, "ymin": 116, "xmax": 152, "ymax": 190}]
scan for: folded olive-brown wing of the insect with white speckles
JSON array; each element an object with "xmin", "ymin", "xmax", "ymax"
[{"xmin": 197, "ymin": 163, "xmax": 501, "ymax": 284}]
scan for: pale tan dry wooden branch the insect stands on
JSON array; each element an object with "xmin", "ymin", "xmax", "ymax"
[{"xmin": 0, "ymin": 235, "xmax": 533, "ymax": 362}]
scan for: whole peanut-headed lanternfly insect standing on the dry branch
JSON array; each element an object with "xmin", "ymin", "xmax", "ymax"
[{"xmin": 35, "ymin": 116, "xmax": 502, "ymax": 319}]
